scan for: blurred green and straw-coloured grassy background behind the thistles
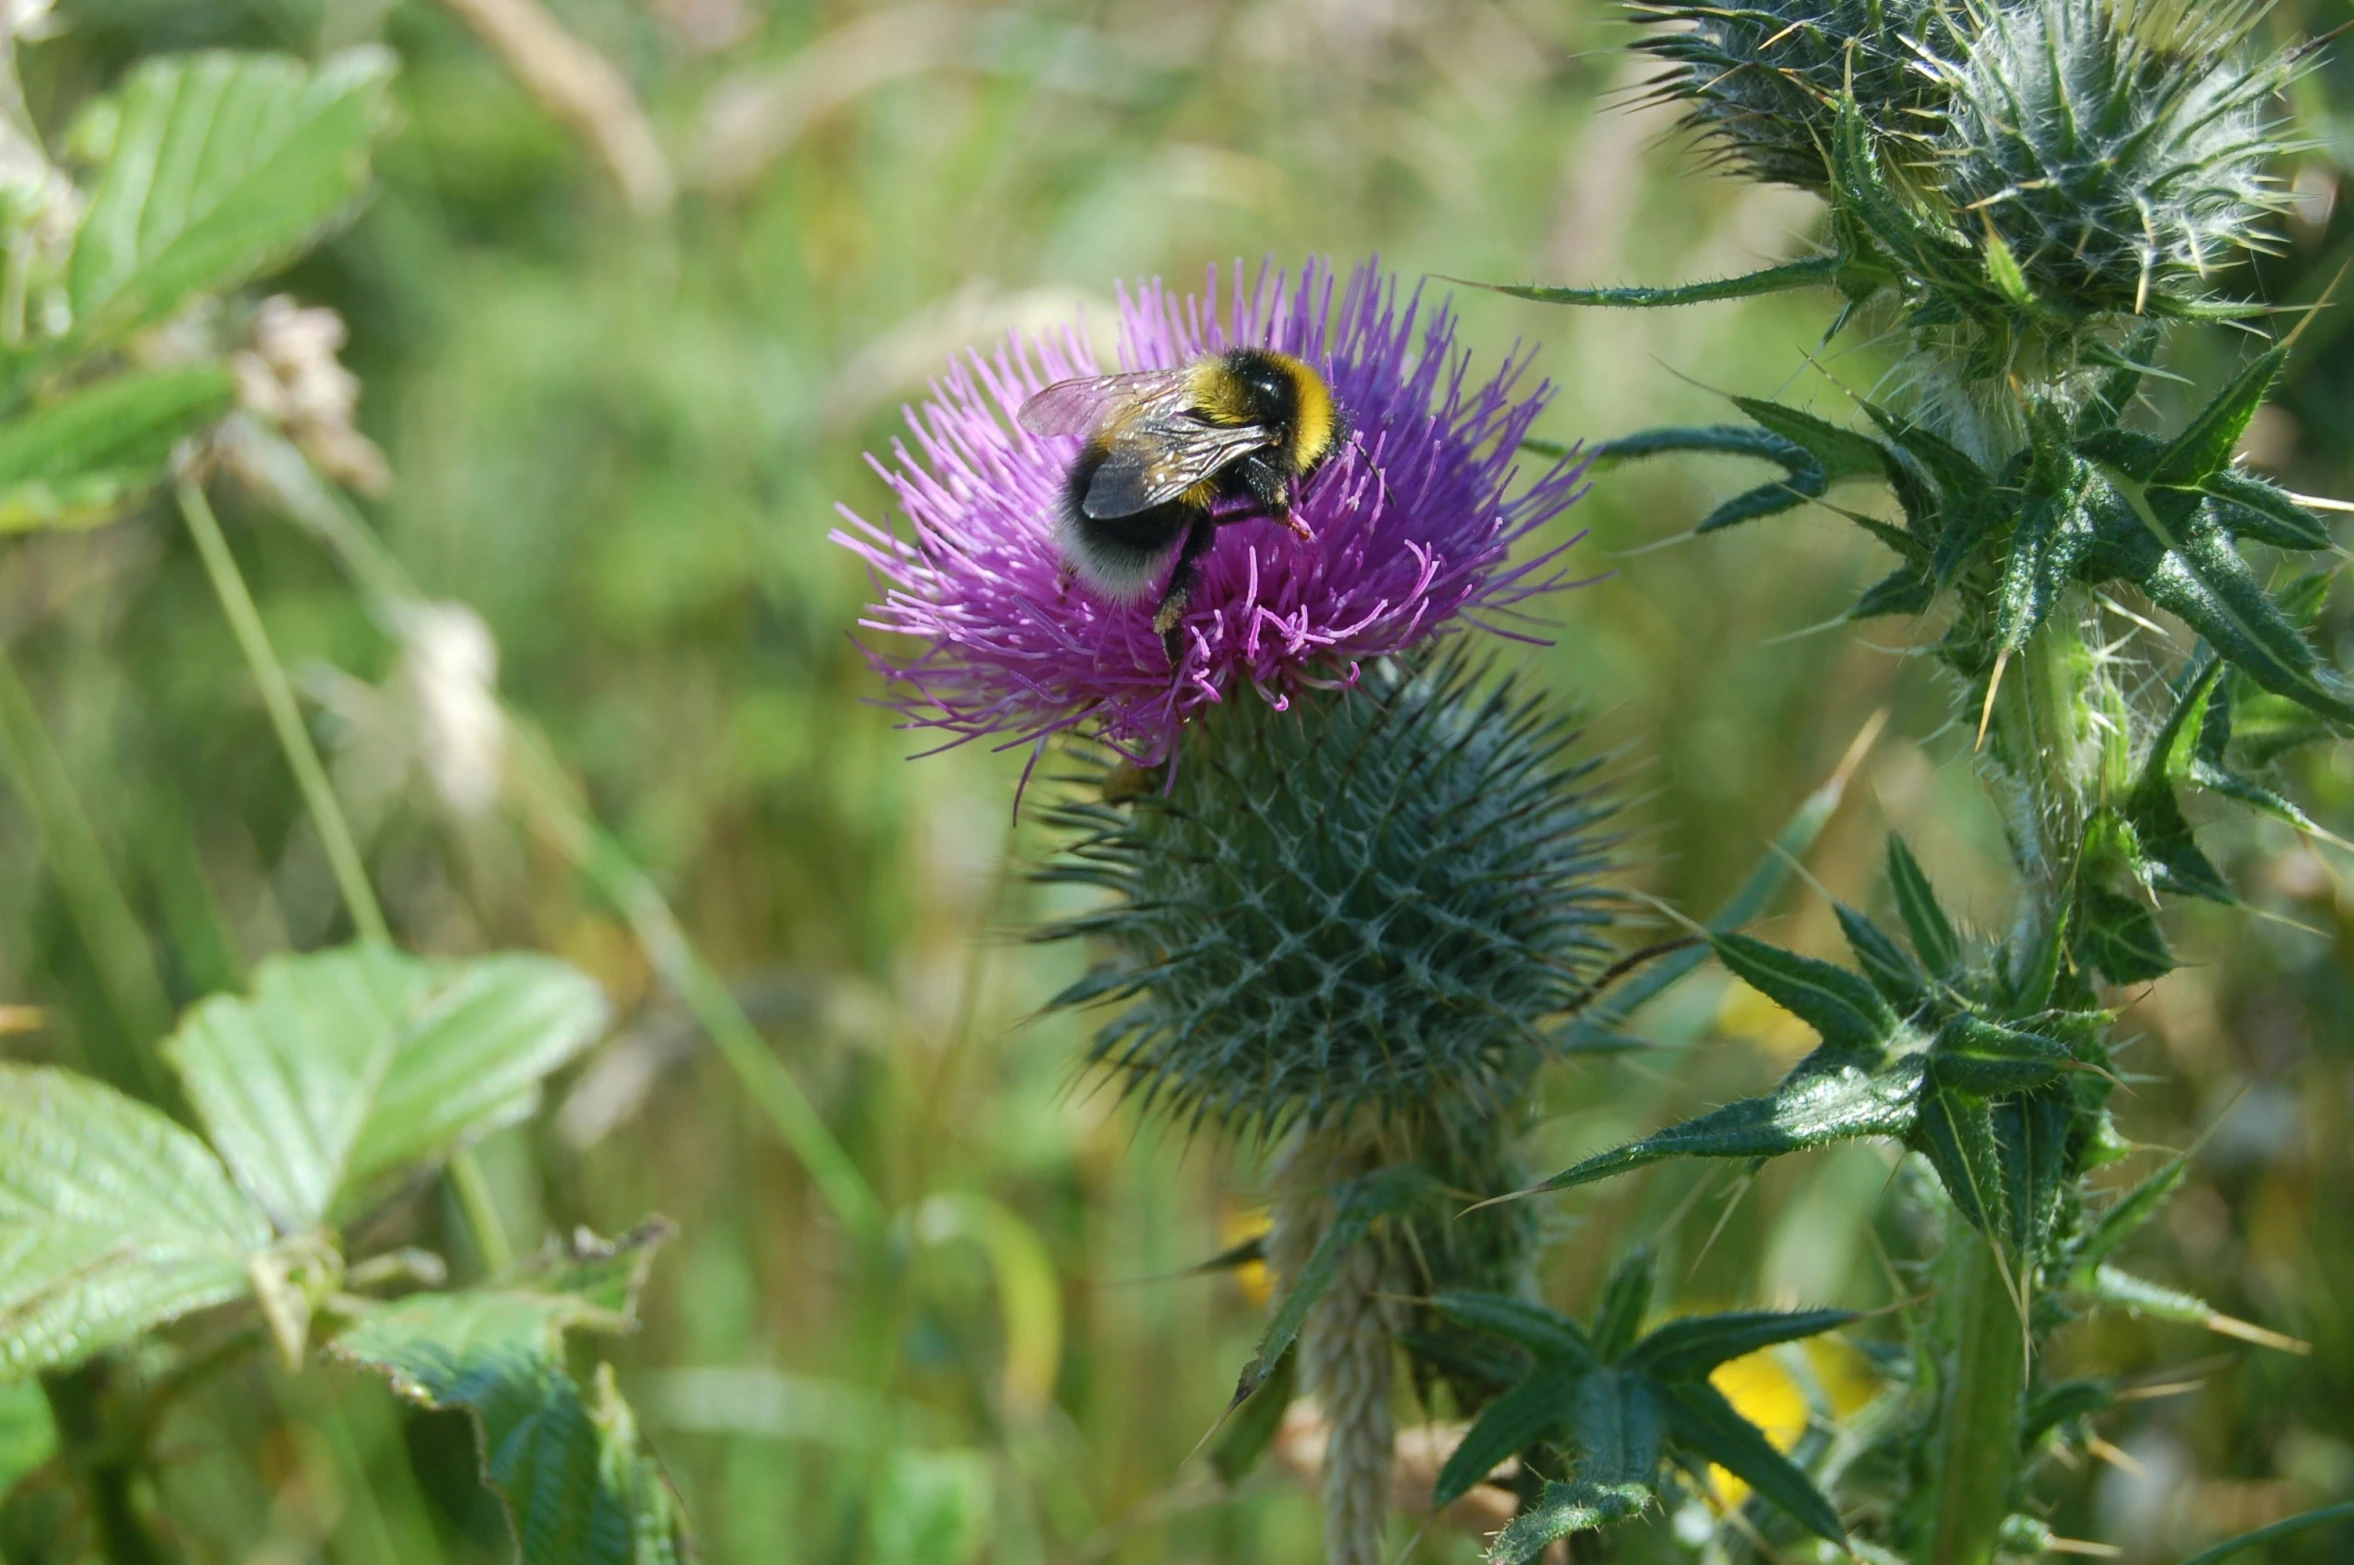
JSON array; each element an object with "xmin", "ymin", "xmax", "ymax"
[{"xmin": 0, "ymin": 0, "xmax": 2354, "ymax": 1565}]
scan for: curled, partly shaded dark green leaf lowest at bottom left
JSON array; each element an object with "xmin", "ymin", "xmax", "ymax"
[{"xmin": 330, "ymin": 1290, "xmax": 687, "ymax": 1565}]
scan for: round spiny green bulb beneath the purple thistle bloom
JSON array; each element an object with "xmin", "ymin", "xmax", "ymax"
[{"xmin": 1043, "ymin": 654, "xmax": 1608, "ymax": 1134}]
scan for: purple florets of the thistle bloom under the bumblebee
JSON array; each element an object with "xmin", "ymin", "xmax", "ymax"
[{"xmin": 833, "ymin": 261, "xmax": 1584, "ymax": 765}]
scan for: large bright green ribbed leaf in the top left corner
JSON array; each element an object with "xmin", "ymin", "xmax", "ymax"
[{"xmin": 66, "ymin": 49, "xmax": 393, "ymax": 341}]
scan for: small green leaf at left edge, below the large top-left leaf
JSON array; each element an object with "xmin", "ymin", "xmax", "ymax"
[{"xmin": 0, "ymin": 365, "xmax": 235, "ymax": 534}]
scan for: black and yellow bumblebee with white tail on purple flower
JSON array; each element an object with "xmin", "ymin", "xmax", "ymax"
[{"xmin": 1017, "ymin": 348, "xmax": 1349, "ymax": 664}]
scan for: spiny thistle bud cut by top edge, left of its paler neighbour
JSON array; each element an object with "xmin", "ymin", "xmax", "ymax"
[{"xmin": 1636, "ymin": 0, "xmax": 1951, "ymax": 191}]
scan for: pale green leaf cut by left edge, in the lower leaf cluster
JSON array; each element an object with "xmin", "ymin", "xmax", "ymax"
[{"xmin": 0, "ymin": 1064, "xmax": 271, "ymax": 1379}]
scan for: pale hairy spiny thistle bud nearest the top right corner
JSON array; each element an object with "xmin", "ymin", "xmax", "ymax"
[{"xmin": 1935, "ymin": 0, "xmax": 2295, "ymax": 318}]
